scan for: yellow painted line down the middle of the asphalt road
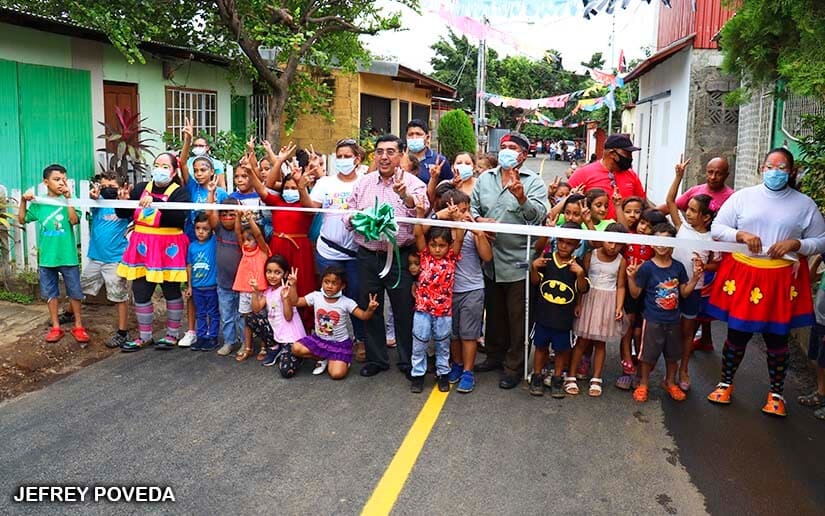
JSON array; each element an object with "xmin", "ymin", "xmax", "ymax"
[{"xmin": 361, "ymin": 387, "xmax": 449, "ymax": 516}]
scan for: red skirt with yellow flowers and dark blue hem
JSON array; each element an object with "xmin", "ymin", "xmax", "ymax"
[{"xmin": 707, "ymin": 253, "xmax": 814, "ymax": 335}]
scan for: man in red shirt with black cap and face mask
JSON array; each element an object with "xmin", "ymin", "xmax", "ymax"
[{"xmin": 567, "ymin": 134, "xmax": 647, "ymax": 219}]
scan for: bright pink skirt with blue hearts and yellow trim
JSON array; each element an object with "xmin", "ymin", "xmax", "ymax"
[{"xmin": 117, "ymin": 226, "xmax": 189, "ymax": 283}]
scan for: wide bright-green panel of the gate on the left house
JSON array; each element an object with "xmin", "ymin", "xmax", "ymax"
[{"xmin": 17, "ymin": 63, "xmax": 95, "ymax": 194}]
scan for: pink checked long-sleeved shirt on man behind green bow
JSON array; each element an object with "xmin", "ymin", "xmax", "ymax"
[{"xmin": 345, "ymin": 172, "xmax": 430, "ymax": 251}]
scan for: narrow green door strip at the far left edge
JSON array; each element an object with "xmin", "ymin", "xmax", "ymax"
[{"xmin": 0, "ymin": 59, "xmax": 21, "ymax": 195}]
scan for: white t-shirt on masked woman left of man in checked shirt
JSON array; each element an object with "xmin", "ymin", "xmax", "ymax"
[{"xmin": 309, "ymin": 174, "xmax": 358, "ymax": 260}]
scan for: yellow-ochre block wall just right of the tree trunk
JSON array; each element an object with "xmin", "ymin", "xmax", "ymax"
[{"xmin": 288, "ymin": 71, "xmax": 361, "ymax": 154}]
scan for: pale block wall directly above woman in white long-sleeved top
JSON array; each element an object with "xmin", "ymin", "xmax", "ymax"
[{"xmin": 733, "ymin": 86, "xmax": 775, "ymax": 190}]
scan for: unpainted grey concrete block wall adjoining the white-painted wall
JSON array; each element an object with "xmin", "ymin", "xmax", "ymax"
[{"xmin": 684, "ymin": 49, "xmax": 739, "ymax": 187}]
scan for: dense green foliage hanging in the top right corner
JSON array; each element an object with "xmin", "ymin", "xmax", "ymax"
[{"xmin": 720, "ymin": 0, "xmax": 825, "ymax": 98}]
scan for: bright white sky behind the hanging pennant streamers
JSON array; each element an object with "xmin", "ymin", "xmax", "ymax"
[{"xmin": 365, "ymin": 0, "xmax": 660, "ymax": 73}]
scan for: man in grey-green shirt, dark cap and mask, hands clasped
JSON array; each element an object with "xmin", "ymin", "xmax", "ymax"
[{"xmin": 470, "ymin": 132, "xmax": 547, "ymax": 389}]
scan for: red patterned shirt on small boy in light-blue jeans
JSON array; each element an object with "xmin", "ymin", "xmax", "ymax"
[{"xmin": 415, "ymin": 248, "xmax": 461, "ymax": 317}]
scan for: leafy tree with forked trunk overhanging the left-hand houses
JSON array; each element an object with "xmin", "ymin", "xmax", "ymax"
[{"xmin": 0, "ymin": 0, "xmax": 418, "ymax": 145}]
